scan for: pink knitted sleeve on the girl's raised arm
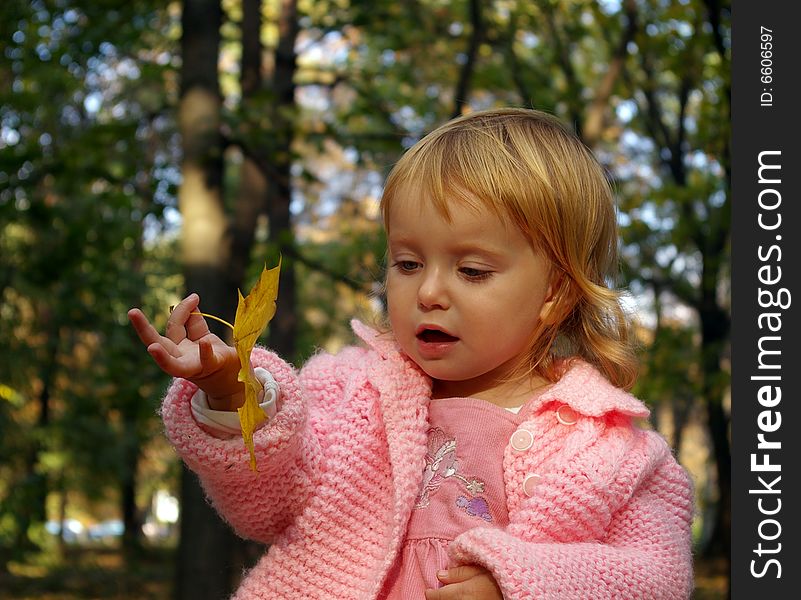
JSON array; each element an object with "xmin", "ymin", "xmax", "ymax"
[{"xmin": 161, "ymin": 348, "xmax": 321, "ymax": 543}]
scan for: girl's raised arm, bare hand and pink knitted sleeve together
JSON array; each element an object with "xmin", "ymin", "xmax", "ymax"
[{"xmin": 129, "ymin": 294, "xmax": 320, "ymax": 541}]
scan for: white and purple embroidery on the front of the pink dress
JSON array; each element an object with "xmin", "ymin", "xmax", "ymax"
[{"xmin": 414, "ymin": 427, "xmax": 492, "ymax": 521}]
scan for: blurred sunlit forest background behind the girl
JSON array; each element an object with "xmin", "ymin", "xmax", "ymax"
[{"xmin": 0, "ymin": 0, "xmax": 731, "ymax": 600}]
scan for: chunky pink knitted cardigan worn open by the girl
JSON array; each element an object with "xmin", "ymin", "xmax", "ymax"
[{"xmin": 162, "ymin": 321, "xmax": 693, "ymax": 600}]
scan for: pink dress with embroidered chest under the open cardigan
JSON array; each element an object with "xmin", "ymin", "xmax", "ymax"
[{"xmin": 379, "ymin": 398, "xmax": 532, "ymax": 600}]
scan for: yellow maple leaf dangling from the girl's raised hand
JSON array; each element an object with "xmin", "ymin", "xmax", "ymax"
[{"xmin": 234, "ymin": 259, "xmax": 281, "ymax": 471}]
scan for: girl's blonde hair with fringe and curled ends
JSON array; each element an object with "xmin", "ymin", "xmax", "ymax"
[{"xmin": 381, "ymin": 108, "xmax": 637, "ymax": 389}]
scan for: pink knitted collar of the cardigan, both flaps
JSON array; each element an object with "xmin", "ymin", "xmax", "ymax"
[{"xmin": 351, "ymin": 319, "xmax": 650, "ymax": 417}]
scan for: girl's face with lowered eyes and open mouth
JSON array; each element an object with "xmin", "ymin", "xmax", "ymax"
[{"xmin": 387, "ymin": 192, "xmax": 550, "ymax": 404}]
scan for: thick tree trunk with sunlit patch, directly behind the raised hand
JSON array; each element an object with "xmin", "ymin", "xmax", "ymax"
[{"xmin": 175, "ymin": 0, "xmax": 235, "ymax": 600}]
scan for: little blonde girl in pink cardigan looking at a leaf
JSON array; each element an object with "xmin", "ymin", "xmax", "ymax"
[{"xmin": 130, "ymin": 109, "xmax": 693, "ymax": 600}]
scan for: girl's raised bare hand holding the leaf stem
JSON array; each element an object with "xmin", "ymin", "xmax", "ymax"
[{"xmin": 128, "ymin": 294, "xmax": 245, "ymax": 410}]
